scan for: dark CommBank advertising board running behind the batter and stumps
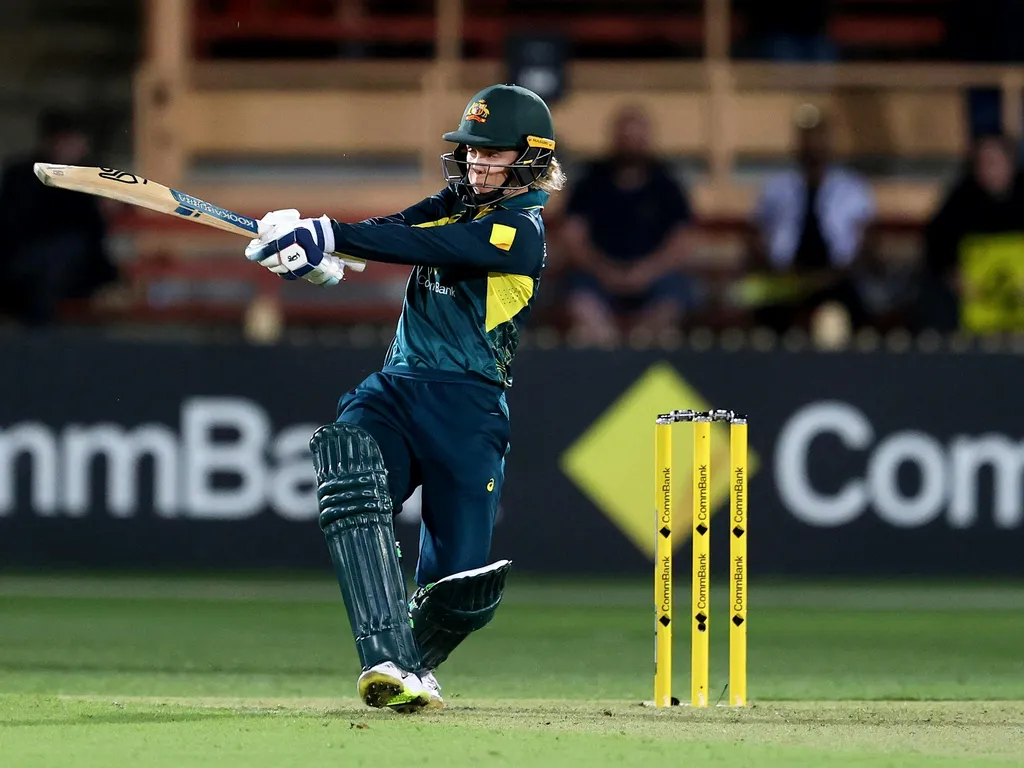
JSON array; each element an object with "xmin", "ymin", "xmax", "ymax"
[{"xmin": 0, "ymin": 334, "xmax": 1024, "ymax": 578}]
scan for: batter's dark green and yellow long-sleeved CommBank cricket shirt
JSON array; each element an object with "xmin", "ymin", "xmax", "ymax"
[{"xmin": 332, "ymin": 188, "xmax": 549, "ymax": 387}]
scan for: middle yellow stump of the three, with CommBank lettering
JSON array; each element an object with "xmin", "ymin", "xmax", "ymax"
[{"xmin": 690, "ymin": 416, "xmax": 711, "ymax": 707}]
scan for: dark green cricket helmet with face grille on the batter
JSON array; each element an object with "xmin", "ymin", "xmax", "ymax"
[{"xmin": 441, "ymin": 85, "xmax": 555, "ymax": 208}]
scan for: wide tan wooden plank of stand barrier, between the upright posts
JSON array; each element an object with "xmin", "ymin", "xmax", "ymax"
[{"xmin": 174, "ymin": 90, "xmax": 968, "ymax": 161}]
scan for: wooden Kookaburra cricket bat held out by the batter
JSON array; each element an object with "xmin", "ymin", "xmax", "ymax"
[{"xmin": 33, "ymin": 163, "xmax": 367, "ymax": 272}]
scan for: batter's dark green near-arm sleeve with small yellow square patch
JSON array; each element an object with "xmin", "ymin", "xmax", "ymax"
[{"xmin": 332, "ymin": 210, "xmax": 544, "ymax": 275}]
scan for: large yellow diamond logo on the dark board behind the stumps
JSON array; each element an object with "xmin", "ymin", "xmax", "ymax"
[{"xmin": 561, "ymin": 364, "xmax": 758, "ymax": 558}]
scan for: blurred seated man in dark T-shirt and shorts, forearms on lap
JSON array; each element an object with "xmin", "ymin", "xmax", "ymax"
[{"xmin": 563, "ymin": 108, "xmax": 692, "ymax": 343}]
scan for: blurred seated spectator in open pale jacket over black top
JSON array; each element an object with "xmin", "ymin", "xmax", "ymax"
[{"xmin": 751, "ymin": 105, "xmax": 876, "ymax": 331}]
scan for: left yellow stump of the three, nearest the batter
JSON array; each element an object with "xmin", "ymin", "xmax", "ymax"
[{"xmin": 654, "ymin": 421, "xmax": 672, "ymax": 707}]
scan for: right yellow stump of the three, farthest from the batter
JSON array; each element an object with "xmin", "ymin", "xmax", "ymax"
[{"xmin": 729, "ymin": 419, "xmax": 748, "ymax": 707}]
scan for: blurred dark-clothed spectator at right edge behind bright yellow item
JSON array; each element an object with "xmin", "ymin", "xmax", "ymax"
[{"xmin": 919, "ymin": 134, "xmax": 1024, "ymax": 332}]
